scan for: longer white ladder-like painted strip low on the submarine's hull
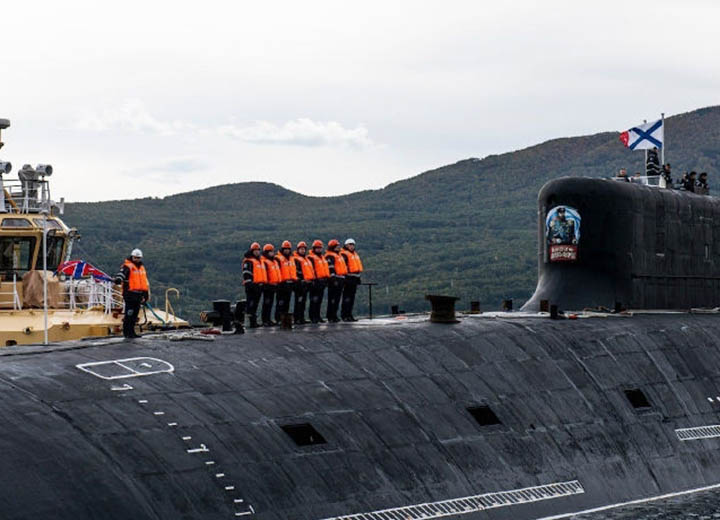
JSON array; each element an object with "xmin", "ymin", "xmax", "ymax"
[{"xmin": 320, "ymin": 480, "xmax": 585, "ymax": 520}]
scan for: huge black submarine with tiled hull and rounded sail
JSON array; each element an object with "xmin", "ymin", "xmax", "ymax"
[{"xmin": 0, "ymin": 178, "xmax": 720, "ymax": 520}]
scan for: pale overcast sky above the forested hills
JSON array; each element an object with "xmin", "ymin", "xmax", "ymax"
[{"xmin": 0, "ymin": 0, "xmax": 720, "ymax": 201}]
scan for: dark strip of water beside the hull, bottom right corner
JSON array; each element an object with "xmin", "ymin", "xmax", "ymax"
[{"xmin": 572, "ymin": 489, "xmax": 720, "ymax": 520}]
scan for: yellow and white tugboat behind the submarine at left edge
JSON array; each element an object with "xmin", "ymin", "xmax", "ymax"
[{"xmin": 0, "ymin": 119, "xmax": 188, "ymax": 346}]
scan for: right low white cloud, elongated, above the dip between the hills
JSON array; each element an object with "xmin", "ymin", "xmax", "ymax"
[{"xmin": 218, "ymin": 118, "xmax": 373, "ymax": 148}]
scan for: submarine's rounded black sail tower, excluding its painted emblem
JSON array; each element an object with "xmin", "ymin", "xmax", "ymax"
[{"xmin": 523, "ymin": 177, "xmax": 720, "ymax": 310}]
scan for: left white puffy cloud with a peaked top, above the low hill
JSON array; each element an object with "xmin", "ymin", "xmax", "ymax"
[{"xmin": 75, "ymin": 99, "xmax": 195, "ymax": 136}]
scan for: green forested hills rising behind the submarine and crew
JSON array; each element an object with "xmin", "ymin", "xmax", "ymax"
[{"xmin": 60, "ymin": 107, "xmax": 720, "ymax": 322}]
